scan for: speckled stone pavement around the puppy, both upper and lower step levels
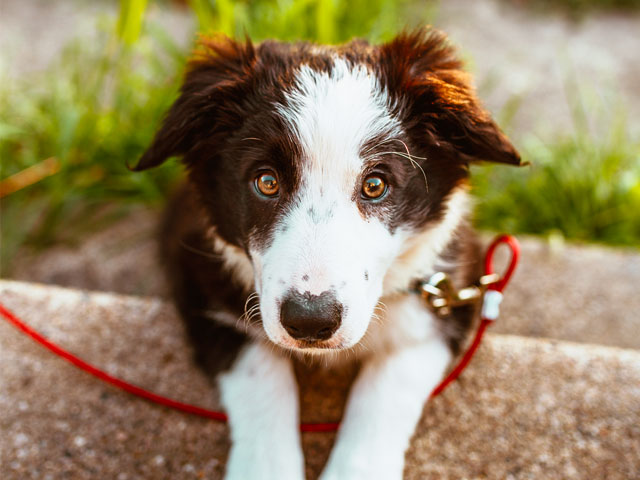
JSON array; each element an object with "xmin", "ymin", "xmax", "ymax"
[{"xmin": 0, "ymin": 209, "xmax": 640, "ymax": 480}]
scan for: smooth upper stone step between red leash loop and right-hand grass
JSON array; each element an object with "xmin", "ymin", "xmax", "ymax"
[{"xmin": 493, "ymin": 237, "xmax": 640, "ymax": 349}]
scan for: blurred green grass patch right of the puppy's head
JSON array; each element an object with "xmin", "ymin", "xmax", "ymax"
[{"xmin": 473, "ymin": 84, "xmax": 640, "ymax": 247}]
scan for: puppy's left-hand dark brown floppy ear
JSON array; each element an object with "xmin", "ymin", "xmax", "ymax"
[{"xmin": 130, "ymin": 36, "xmax": 256, "ymax": 171}]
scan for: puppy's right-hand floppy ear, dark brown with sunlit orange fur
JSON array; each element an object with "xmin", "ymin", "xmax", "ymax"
[{"xmin": 380, "ymin": 29, "xmax": 522, "ymax": 165}]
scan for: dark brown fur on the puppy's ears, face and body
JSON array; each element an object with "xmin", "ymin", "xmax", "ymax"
[{"xmin": 134, "ymin": 30, "xmax": 520, "ymax": 372}]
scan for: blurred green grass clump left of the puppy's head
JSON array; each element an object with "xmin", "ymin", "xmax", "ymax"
[{"xmin": 0, "ymin": 21, "xmax": 184, "ymax": 272}]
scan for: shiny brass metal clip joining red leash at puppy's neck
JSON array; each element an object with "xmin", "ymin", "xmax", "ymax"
[{"xmin": 419, "ymin": 272, "xmax": 500, "ymax": 317}]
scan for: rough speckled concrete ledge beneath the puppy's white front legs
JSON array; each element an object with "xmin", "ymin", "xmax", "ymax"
[{"xmin": 0, "ymin": 281, "xmax": 640, "ymax": 480}]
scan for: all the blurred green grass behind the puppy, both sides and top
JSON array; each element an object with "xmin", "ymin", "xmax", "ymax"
[{"xmin": 0, "ymin": 0, "xmax": 640, "ymax": 274}]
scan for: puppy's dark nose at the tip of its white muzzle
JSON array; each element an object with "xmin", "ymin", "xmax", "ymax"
[{"xmin": 280, "ymin": 290, "xmax": 342, "ymax": 341}]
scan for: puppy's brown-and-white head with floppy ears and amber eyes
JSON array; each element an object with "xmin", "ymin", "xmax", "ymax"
[{"xmin": 134, "ymin": 30, "xmax": 520, "ymax": 351}]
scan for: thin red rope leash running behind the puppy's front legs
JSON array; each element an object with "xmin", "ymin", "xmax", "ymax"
[{"xmin": 0, "ymin": 235, "xmax": 520, "ymax": 432}]
